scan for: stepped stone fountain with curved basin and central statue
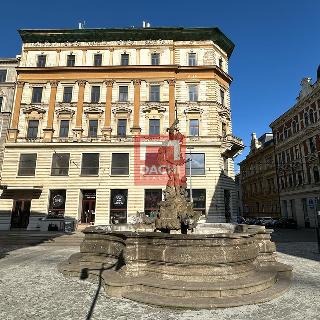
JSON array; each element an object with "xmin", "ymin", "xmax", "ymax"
[{"xmin": 59, "ymin": 123, "xmax": 292, "ymax": 309}]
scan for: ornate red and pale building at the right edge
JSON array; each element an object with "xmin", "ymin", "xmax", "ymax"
[{"xmin": 270, "ymin": 68, "xmax": 320, "ymax": 227}]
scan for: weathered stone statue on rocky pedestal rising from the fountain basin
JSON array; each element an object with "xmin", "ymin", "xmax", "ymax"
[{"xmin": 155, "ymin": 120, "xmax": 200, "ymax": 234}]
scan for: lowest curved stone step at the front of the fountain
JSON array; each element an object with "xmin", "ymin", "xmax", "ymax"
[{"xmin": 124, "ymin": 274, "xmax": 290, "ymax": 309}]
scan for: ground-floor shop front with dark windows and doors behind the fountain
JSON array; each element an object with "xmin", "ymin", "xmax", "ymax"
[{"xmin": 0, "ymin": 185, "xmax": 234, "ymax": 230}]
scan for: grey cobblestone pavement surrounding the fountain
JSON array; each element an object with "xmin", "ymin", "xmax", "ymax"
[{"xmin": 0, "ymin": 230, "xmax": 320, "ymax": 320}]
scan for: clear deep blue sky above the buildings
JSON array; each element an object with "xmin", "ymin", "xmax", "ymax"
[{"xmin": 0, "ymin": 0, "xmax": 320, "ymax": 170}]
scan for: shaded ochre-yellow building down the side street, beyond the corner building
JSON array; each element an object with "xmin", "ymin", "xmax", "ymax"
[{"xmin": 239, "ymin": 133, "xmax": 280, "ymax": 217}]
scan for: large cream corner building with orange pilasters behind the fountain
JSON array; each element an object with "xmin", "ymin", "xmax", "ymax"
[{"xmin": 0, "ymin": 28, "xmax": 243, "ymax": 229}]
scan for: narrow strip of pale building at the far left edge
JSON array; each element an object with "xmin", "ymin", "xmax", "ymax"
[{"xmin": 0, "ymin": 58, "xmax": 18, "ymax": 173}]
